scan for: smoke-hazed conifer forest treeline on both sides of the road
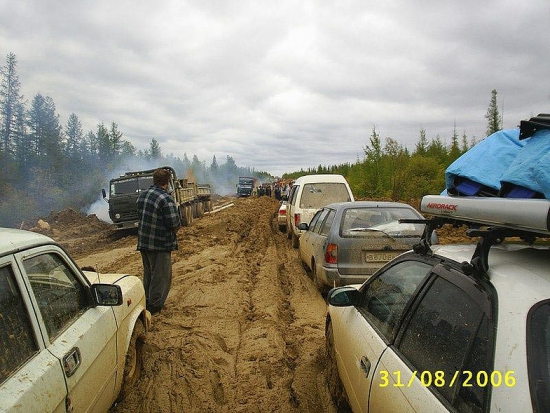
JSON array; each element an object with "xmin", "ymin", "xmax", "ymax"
[{"xmin": 0, "ymin": 53, "xmax": 499, "ymax": 227}]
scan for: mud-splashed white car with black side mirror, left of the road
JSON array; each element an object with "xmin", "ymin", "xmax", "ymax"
[{"xmin": 0, "ymin": 228, "xmax": 150, "ymax": 412}]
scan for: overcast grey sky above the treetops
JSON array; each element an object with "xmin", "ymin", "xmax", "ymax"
[{"xmin": 0, "ymin": 0, "xmax": 550, "ymax": 175}]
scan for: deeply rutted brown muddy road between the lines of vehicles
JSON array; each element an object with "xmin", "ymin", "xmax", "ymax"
[{"xmin": 44, "ymin": 197, "xmax": 335, "ymax": 413}]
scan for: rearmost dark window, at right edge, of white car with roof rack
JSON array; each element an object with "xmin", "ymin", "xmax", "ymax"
[{"xmin": 527, "ymin": 301, "xmax": 550, "ymax": 412}]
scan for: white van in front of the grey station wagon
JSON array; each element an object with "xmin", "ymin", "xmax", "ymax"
[{"xmin": 286, "ymin": 174, "xmax": 355, "ymax": 248}]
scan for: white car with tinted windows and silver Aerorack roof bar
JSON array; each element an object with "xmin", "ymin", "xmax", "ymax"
[{"xmin": 326, "ymin": 196, "xmax": 550, "ymax": 413}]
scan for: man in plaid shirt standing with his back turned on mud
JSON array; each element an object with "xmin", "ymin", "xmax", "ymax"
[{"xmin": 137, "ymin": 169, "xmax": 181, "ymax": 314}]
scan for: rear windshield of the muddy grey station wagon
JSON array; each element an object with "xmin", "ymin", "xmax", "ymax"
[{"xmin": 341, "ymin": 207, "xmax": 424, "ymax": 238}]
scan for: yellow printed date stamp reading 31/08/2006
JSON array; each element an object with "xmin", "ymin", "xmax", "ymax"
[{"xmin": 379, "ymin": 370, "xmax": 516, "ymax": 387}]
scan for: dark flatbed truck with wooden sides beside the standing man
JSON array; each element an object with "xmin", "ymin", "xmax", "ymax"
[{"xmin": 102, "ymin": 166, "xmax": 212, "ymax": 230}]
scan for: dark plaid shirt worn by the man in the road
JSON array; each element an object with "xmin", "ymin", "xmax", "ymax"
[{"xmin": 136, "ymin": 185, "xmax": 181, "ymax": 251}]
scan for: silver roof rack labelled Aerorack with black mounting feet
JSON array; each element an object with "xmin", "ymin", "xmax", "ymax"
[{"xmin": 400, "ymin": 195, "xmax": 550, "ymax": 278}]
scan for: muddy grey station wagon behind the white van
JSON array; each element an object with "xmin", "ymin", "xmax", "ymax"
[{"xmin": 298, "ymin": 201, "xmax": 424, "ymax": 292}]
